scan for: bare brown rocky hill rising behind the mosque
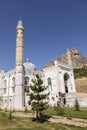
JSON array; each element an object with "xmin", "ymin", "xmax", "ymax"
[{"xmin": 44, "ymin": 48, "xmax": 87, "ymax": 68}]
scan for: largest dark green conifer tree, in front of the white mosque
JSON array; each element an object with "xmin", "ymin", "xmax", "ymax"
[{"xmin": 29, "ymin": 74, "xmax": 49, "ymax": 119}]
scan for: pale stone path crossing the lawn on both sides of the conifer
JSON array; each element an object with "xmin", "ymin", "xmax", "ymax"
[{"xmin": 13, "ymin": 112, "xmax": 87, "ymax": 127}]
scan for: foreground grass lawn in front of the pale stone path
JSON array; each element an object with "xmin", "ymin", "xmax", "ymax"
[{"xmin": 0, "ymin": 112, "xmax": 87, "ymax": 130}]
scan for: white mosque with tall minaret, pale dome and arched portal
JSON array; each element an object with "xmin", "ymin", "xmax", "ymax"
[{"xmin": 0, "ymin": 20, "xmax": 87, "ymax": 110}]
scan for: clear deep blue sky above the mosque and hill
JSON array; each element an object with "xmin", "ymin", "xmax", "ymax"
[{"xmin": 0, "ymin": 0, "xmax": 87, "ymax": 70}]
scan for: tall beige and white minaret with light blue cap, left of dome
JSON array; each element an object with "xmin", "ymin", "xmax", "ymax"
[{"xmin": 14, "ymin": 20, "xmax": 24, "ymax": 109}]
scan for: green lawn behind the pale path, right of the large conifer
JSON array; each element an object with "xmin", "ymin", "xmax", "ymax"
[{"xmin": 43, "ymin": 108, "xmax": 87, "ymax": 119}]
